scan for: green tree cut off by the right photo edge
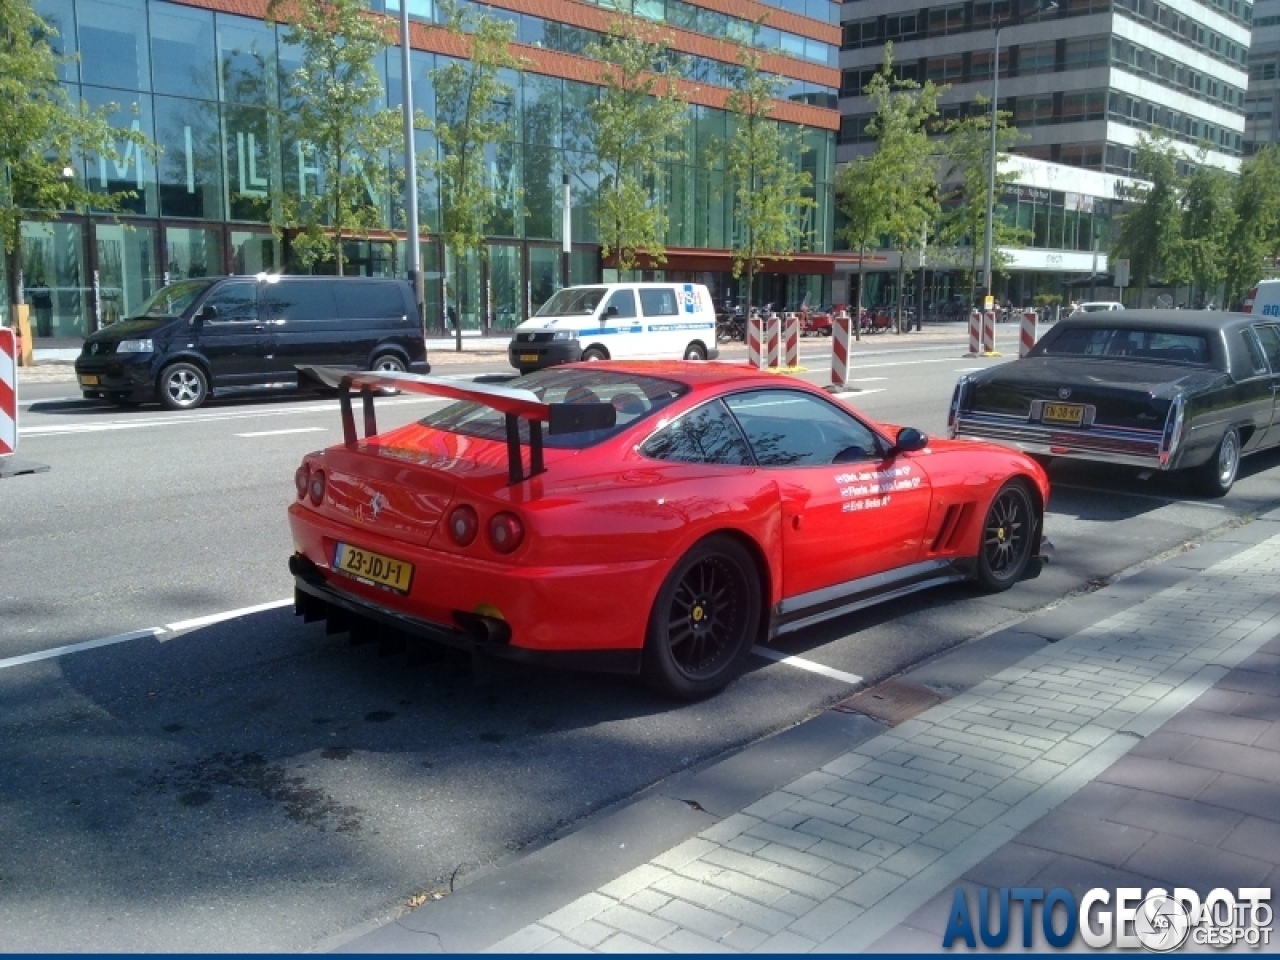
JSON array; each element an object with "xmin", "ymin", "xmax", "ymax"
[{"xmin": 1222, "ymin": 146, "xmax": 1280, "ymax": 307}]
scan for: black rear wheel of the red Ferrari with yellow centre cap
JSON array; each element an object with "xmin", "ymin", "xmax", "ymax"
[{"xmin": 641, "ymin": 536, "xmax": 760, "ymax": 700}]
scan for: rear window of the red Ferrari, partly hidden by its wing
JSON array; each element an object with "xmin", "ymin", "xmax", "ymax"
[{"xmin": 419, "ymin": 367, "xmax": 689, "ymax": 449}]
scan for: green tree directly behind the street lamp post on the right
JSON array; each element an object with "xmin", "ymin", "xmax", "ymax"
[{"xmin": 938, "ymin": 95, "xmax": 1030, "ymax": 303}]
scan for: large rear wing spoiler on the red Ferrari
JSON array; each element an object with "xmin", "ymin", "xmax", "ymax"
[{"xmin": 298, "ymin": 366, "xmax": 617, "ymax": 484}]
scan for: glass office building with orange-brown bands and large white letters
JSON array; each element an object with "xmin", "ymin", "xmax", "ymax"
[{"xmin": 5, "ymin": 0, "xmax": 840, "ymax": 346}]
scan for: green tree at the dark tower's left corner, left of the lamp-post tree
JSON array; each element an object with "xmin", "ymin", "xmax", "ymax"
[{"xmin": 859, "ymin": 44, "xmax": 947, "ymax": 332}]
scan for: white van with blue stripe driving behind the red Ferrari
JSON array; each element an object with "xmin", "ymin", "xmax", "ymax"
[{"xmin": 509, "ymin": 283, "xmax": 719, "ymax": 374}]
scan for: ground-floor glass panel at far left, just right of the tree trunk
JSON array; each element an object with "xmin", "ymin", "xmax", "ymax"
[{"xmin": 22, "ymin": 223, "xmax": 92, "ymax": 337}]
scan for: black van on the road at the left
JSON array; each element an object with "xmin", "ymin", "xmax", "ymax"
[{"xmin": 76, "ymin": 275, "xmax": 431, "ymax": 410}]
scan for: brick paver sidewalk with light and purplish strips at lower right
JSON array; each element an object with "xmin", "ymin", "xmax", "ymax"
[{"xmin": 490, "ymin": 536, "xmax": 1280, "ymax": 952}]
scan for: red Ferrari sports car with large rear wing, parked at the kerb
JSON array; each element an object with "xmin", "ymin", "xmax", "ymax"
[{"xmin": 289, "ymin": 362, "xmax": 1048, "ymax": 698}]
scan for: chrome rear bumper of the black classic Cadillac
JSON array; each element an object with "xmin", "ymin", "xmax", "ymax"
[{"xmin": 954, "ymin": 412, "xmax": 1170, "ymax": 470}]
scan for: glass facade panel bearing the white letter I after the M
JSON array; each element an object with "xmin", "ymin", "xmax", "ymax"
[{"xmin": 155, "ymin": 97, "xmax": 223, "ymax": 220}]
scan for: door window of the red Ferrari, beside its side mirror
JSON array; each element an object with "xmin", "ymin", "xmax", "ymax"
[{"xmin": 726, "ymin": 389, "xmax": 881, "ymax": 467}]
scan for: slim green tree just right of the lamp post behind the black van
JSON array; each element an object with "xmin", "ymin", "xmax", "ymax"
[{"xmin": 424, "ymin": 3, "xmax": 521, "ymax": 351}]
